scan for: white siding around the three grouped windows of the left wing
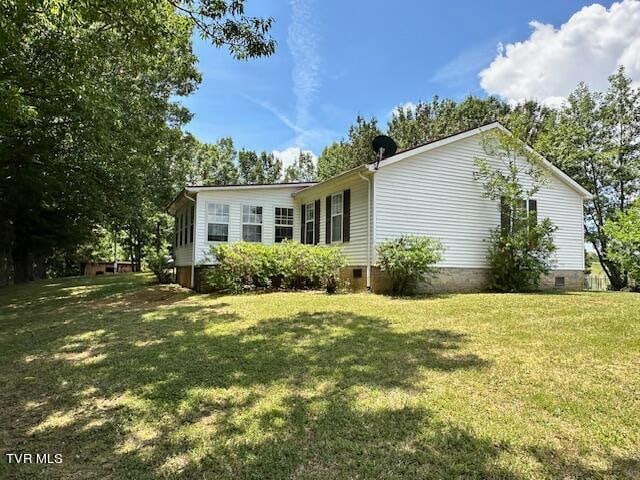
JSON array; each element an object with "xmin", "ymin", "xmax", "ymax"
[{"xmin": 195, "ymin": 186, "xmax": 301, "ymax": 264}]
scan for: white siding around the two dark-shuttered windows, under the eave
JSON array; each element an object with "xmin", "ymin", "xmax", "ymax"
[{"xmin": 294, "ymin": 173, "xmax": 373, "ymax": 266}]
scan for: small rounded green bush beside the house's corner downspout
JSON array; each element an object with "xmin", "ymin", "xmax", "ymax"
[{"xmin": 377, "ymin": 235, "xmax": 444, "ymax": 295}]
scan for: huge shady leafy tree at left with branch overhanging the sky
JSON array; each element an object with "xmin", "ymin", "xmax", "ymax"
[{"xmin": 0, "ymin": 0, "xmax": 275, "ymax": 281}]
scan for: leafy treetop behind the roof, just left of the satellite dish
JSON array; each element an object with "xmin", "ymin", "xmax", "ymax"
[{"xmin": 318, "ymin": 115, "xmax": 381, "ymax": 180}]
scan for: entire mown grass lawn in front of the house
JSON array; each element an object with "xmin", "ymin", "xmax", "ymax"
[{"xmin": 0, "ymin": 275, "xmax": 640, "ymax": 480}]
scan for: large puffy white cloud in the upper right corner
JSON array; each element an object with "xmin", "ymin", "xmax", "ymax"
[{"xmin": 480, "ymin": 0, "xmax": 640, "ymax": 104}]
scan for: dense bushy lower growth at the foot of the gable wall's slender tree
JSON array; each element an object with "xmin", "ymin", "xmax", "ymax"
[{"xmin": 487, "ymin": 218, "xmax": 556, "ymax": 292}]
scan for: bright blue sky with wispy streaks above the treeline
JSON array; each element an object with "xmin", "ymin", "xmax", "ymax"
[{"xmin": 182, "ymin": 0, "xmax": 640, "ymax": 165}]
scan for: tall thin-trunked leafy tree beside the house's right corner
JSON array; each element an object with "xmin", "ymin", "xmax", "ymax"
[{"xmin": 536, "ymin": 68, "xmax": 640, "ymax": 290}]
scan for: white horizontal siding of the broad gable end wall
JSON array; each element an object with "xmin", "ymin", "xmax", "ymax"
[{"xmin": 374, "ymin": 135, "xmax": 584, "ymax": 269}]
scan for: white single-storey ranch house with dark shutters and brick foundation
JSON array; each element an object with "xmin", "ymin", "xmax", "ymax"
[{"xmin": 168, "ymin": 122, "xmax": 591, "ymax": 291}]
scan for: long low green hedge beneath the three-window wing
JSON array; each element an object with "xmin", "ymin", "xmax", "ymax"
[{"xmin": 203, "ymin": 241, "xmax": 344, "ymax": 292}]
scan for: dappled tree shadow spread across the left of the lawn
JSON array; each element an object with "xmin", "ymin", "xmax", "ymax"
[{"xmin": 0, "ymin": 288, "xmax": 632, "ymax": 478}]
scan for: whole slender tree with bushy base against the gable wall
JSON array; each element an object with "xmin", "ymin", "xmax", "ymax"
[{"xmin": 475, "ymin": 131, "xmax": 556, "ymax": 292}]
